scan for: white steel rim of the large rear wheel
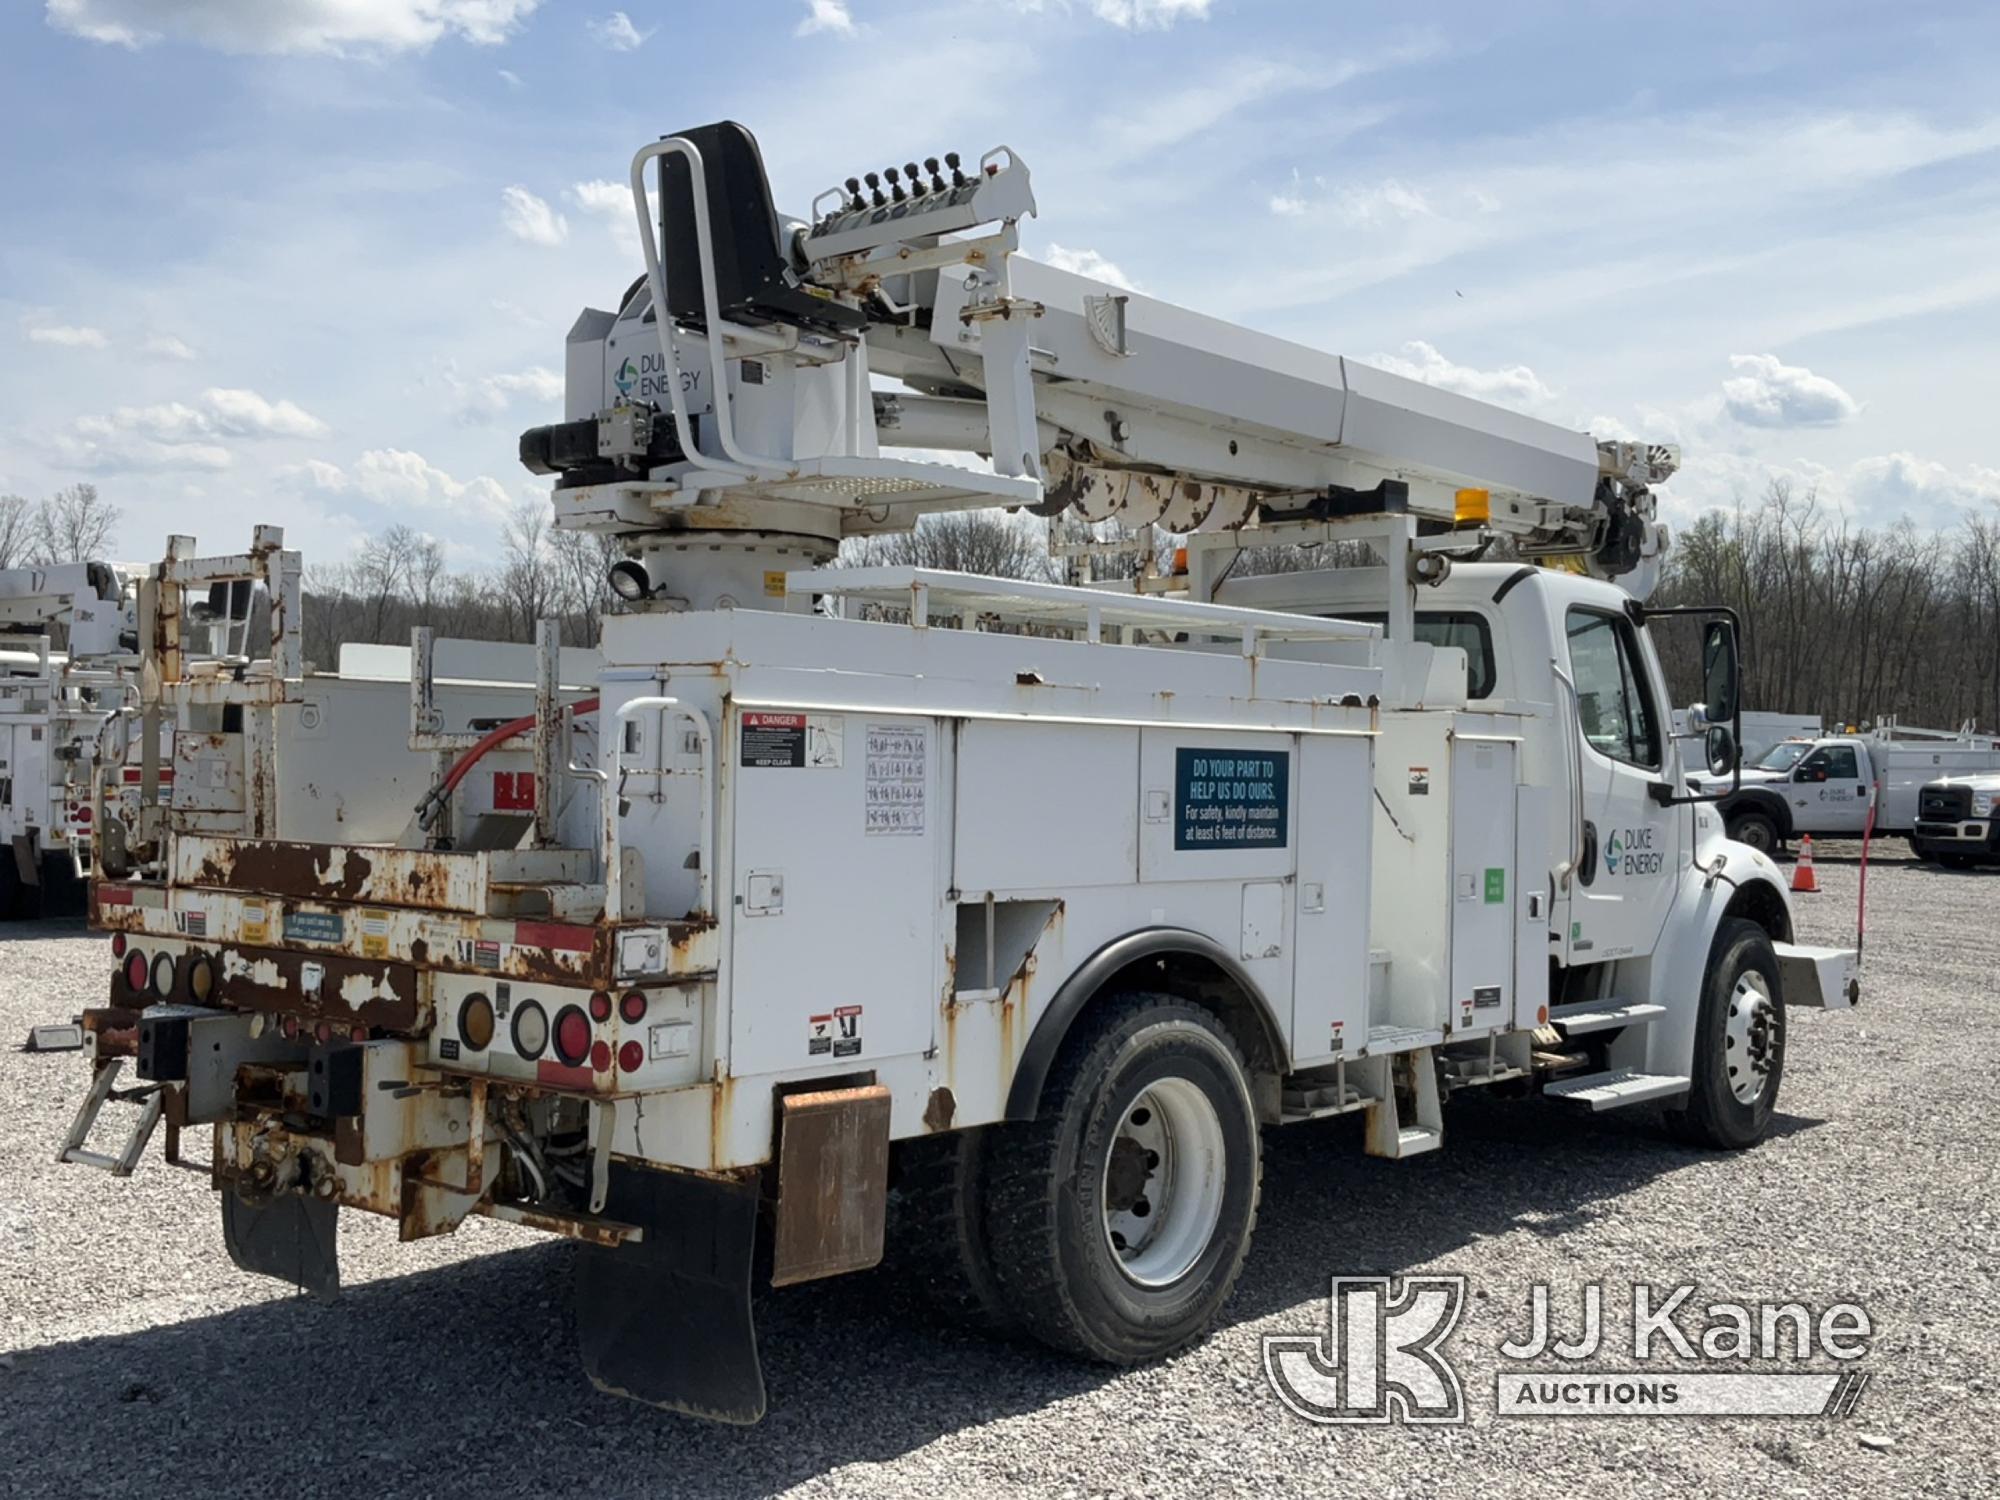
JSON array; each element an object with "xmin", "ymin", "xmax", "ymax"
[{"xmin": 1100, "ymin": 1078, "xmax": 1228, "ymax": 1286}]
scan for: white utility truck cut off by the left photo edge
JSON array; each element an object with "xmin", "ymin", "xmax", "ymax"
[{"xmin": 0, "ymin": 562, "xmax": 138, "ymax": 920}]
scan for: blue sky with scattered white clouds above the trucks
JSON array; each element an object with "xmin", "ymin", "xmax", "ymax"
[{"xmin": 0, "ymin": 0, "xmax": 2000, "ymax": 564}]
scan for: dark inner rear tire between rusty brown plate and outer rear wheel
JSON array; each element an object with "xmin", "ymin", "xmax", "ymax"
[{"xmin": 894, "ymin": 1126, "xmax": 1016, "ymax": 1334}]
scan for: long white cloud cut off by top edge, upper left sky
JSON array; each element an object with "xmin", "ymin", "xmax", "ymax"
[{"xmin": 44, "ymin": 0, "xmax": 540, "ymax": 54}]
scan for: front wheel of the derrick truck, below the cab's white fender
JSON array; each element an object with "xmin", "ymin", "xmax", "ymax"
[{"xmin": 1666, "ymin": 918, "xmax": 1784, "ymax": 1150}]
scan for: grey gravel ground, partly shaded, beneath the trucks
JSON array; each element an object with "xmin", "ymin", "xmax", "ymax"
[{"xmin": 0, "ymin": 846, "xmax": 2000, "ymax": 1498}]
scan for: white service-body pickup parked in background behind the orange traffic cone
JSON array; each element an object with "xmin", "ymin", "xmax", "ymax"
[{"xmin": 1696, "ymin": 734, "xmax": 2000, "ymax": 854}]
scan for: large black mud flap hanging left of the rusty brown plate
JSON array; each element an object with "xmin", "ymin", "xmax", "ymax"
[{"xmin": 576, "ymin": 1162, "xmax": 764, "ymax": 1426}]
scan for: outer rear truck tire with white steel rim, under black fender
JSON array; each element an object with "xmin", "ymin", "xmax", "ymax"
[{"xmin": 986, "ymin": 992, "xmax": 1264, "ymax": 1364}]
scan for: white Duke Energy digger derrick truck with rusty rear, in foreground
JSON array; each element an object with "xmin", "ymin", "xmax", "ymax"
[{"xmin": 72, "ymin": 122, "xmax": 1858, "ymax": 1422}]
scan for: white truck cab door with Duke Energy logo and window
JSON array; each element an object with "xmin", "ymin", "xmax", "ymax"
[{"xmin": 1564, "ymin": 606, "xmax": 1684, "ymax": 964}]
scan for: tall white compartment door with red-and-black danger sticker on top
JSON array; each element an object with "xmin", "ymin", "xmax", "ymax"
[{"xmin": 722, "ymin": 710, "xmax": 950, "ymax": 1078}]
